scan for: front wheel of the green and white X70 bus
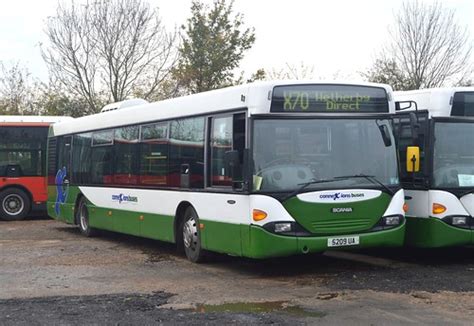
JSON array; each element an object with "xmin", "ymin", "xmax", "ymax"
[{"xmin": 181, "ymin": 207, "xmax": 204, "ymax": 263}]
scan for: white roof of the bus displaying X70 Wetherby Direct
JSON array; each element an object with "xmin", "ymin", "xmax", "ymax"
[{"xmin": 53, "ymin": 80, "xmax": 395, "ymax": 135}]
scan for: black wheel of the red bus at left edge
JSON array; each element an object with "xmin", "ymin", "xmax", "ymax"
[{"xmin": 0, "ymin": 188, "xmax": 31, "ymax": 221}]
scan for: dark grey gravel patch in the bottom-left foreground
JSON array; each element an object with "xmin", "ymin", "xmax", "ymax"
[{"xmin": 0, "ymin": 293, "xmax": 312, "ymax": 325}]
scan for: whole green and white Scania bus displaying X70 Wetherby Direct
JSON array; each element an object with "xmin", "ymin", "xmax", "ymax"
[{"xmin": 48, "ymin": 81, "xmax": 405, "ymax": 262}]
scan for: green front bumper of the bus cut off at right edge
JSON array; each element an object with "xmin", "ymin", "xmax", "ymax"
[{"xmin": 405, "ymin": 216, "xmax": 474, "ymax": 248}]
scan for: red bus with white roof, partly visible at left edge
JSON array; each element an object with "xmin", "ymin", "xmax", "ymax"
[{"xmin": 0, "ymin": 116, "xmax": 71, "ymax": 221}]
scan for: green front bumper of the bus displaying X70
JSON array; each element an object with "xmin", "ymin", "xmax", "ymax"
[{"xmin": 243, "ymin": 223, "xmax": 405, "ymax": 258}]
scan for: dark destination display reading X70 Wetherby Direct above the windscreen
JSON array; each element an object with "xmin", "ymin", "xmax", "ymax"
[{"xmin": 270, "ymin": 85, "xmax": 389, "ymax": 113}]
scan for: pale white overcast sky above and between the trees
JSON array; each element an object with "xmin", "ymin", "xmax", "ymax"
[{"xmin": 0, "ymin": 0, "xmax": 474, "ymax": 79}]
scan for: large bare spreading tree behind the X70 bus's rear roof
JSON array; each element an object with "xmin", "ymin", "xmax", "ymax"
[{"xmin": 42, "ymin": 0, "xmax": 177, "ymax": 113}]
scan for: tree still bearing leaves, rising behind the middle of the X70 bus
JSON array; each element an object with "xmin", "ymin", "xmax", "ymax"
[{"xmin": 174, "ymin": 0, "xmax": 255, "ymax": 93}]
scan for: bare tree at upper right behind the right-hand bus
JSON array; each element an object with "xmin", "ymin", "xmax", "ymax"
[{"xmin": 372, "ymin": 0, "xmax": 472, "ymax": 89}]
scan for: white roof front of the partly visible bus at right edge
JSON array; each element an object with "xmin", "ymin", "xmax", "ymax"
[{"xmin": 393, "ymin": 87, "xmax": 474, "ymax": 117}]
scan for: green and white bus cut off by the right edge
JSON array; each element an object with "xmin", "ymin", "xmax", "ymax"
[{"xmin": 395, "ymin": 87, "xmax": 474, "ymax": 247}]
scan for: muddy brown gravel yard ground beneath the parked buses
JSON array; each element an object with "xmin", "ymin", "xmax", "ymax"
[{"xmin": 0, "ymin": 219, "xmax": 474, "ymax": 325}]
